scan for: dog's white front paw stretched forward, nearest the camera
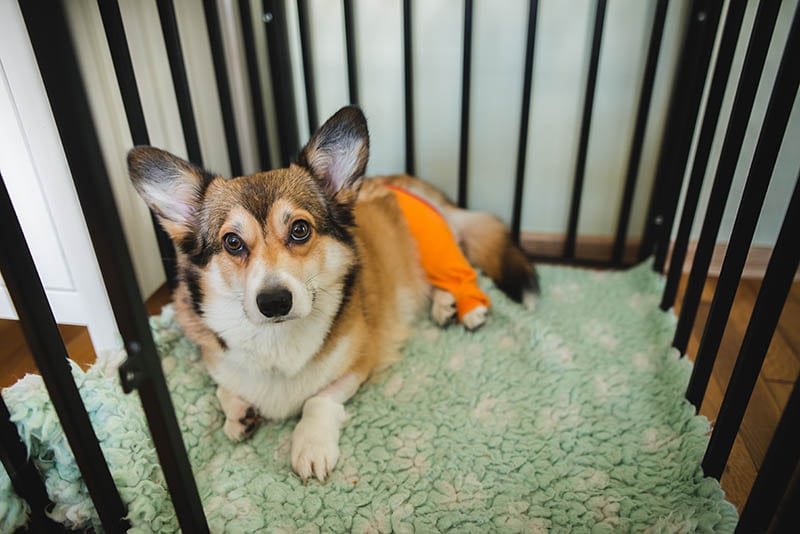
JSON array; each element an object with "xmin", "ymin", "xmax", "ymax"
[{"xmin": 292, "ymin": 397, "xmax": 346, "ymax": 482}]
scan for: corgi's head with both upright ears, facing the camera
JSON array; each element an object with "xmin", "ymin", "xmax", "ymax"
[{"xmin": 128, "ymin": 107, "xmax": 369, "ymax": 350}]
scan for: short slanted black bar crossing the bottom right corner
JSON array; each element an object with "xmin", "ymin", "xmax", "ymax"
[{"xmin": 736, "ymin": 374, "xmax": 800, "ymax": 532}]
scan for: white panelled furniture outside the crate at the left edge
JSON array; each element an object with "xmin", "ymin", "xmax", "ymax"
[{"xmin": 0, "ymin": 0, "xmax": 120, "ymax": 350}]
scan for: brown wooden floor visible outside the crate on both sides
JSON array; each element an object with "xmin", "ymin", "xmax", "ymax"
[{"xmin": 0, "ymin": 277, "xmax": 800, "ymax": 511}]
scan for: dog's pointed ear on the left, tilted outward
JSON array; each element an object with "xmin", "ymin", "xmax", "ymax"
[{"xmin": 128, "ymin": 146, "xmax": 214, "ymax": 242}]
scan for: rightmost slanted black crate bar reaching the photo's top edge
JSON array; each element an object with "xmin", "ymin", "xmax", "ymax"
[{"xmin": 672, "ymin": 2, "xmax": 779, "ymax": 354}]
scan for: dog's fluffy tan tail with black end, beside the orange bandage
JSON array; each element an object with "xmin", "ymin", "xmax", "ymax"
[{"xmin": 447, "ymin": 207, "xmax": 539, "ymax": 308}]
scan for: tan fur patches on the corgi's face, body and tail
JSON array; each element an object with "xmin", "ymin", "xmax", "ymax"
[{"xmin": 174, "ymin": 171, "xmax": 508, "ymax": 398}]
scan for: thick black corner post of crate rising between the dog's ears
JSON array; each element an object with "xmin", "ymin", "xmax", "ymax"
[{"xmin": 263, "ymin": 0, "xmax": 300, "ymax": 166}]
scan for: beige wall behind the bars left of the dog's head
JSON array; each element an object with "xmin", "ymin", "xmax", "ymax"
[{"xmin": 61, "ymin": 0, "xmax": 272, "ymax": 296}]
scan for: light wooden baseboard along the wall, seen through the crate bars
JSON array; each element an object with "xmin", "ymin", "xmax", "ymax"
[{"xmin": 520, "ymin": 232, "xmax": 788, "ymax": 280}]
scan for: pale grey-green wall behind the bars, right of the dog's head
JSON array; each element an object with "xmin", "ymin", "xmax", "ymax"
[{"xmin": 300, "ymin": 0, "xmax": 800, "ymax": 245}]
